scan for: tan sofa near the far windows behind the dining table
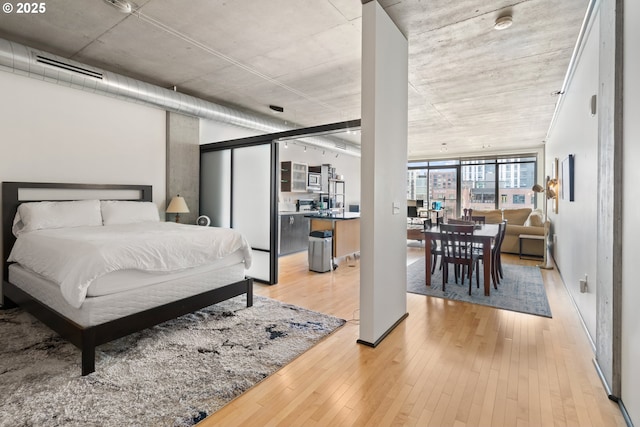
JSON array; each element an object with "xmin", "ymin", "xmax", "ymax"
[{"xmin": 473, "ymin": 208, "xmax": 549, "ymax": 257}]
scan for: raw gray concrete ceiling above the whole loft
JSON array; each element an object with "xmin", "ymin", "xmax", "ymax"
[{"xmin": 0, "ymin": 0, "xmax": 588, "ymax": 159}]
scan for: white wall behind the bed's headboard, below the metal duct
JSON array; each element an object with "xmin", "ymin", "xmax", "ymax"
[{"xmin": 0, "ymin": 71, "xmax": 166, "ymax": 270}]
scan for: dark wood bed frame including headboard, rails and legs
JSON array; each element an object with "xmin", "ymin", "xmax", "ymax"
[{"xmin": 2, "ymin": 182, "xmax": 253, "ymax": 375}]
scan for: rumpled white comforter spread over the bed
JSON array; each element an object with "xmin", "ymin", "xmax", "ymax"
[{"xmin": 9, "ymin": 222, "xmax": 251, "ymax": 308}]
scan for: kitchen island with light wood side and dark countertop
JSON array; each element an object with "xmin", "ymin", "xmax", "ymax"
[{"xmin": 305, "ymin": 212, "xmax": 360, "ymax": 258}]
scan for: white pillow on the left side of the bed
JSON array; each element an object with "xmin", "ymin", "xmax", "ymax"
[{"xmin": 12, "ymin": 200, "xmax": 102, "ymax": 237}]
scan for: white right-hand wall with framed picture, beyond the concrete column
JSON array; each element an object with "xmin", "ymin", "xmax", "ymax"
[{"xmin": 545, "ymin": 10, "xmax": 600, "ymax": 340}]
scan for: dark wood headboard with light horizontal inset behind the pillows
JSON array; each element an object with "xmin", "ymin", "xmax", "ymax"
[{"xmin": 2, "ymin": 182, "xmax": 153, "ymax": 280}]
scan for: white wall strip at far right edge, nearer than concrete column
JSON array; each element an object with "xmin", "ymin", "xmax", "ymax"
[{"xmin": 622, "ymin": 0, "xmax": 640, "ymax": 426}]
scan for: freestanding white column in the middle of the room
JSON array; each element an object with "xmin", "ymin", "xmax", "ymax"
[{"xmin": 358, "ymin": 1, "xmax": 408, "ymax": 346}]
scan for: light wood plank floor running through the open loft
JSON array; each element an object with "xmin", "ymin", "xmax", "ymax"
[{"xmin": 200, "ymin": 247, "xmax": 625, "ymax": 427}]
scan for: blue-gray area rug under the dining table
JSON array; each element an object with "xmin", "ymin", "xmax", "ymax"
[{"xmin": 407, "ymin": 260, "xmax": 551, "ymax": 317}]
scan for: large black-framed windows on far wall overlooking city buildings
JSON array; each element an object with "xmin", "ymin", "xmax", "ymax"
[{"xmin": 407, "ymin": 156, "xmax": 537, "ymax": 218}]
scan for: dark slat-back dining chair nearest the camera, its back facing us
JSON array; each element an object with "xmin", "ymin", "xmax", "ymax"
[{"xmin": 440, "ymin": 224, "xmax": 480, "ymax": 295}]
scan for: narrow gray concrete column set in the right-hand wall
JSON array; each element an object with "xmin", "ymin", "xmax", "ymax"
[{"xmin": 596, "ymin": 0, "xmax": 624, "ymax": 399}]
